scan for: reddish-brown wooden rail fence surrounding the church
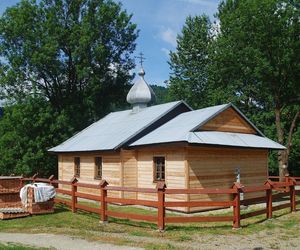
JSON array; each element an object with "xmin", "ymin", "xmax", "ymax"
[{"xmin": 21, "ymin": 175, "xmax": 300, "ymax": 231}]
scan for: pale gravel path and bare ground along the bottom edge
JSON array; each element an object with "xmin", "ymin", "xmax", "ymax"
[{"xmin": 0, "ymin": 229, "xmax": 300, "ymax": 250}]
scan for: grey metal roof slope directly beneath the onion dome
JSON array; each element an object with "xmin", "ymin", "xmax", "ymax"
[{"xmin": 49, "ymin": 101, "xmax": 187, "ymax": 152}]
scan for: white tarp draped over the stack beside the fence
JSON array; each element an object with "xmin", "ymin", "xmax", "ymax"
[{"xmin": 20, "ymin": 182, "xmax": 56, "ymax": 207}]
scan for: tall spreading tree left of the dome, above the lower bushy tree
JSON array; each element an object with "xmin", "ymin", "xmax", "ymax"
[{"xmin": 0, "ymin": 0, "xmax": 137, "ymax": 130}]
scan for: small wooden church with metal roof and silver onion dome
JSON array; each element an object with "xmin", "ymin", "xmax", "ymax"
[{"xmin": 49, "ymin": 66, "xmax": 285, "ymax": 212}]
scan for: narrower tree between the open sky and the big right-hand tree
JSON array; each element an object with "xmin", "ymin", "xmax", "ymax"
[{"xmin": 168, "ymin": 15, "xmax": 213, "ymax": 108}]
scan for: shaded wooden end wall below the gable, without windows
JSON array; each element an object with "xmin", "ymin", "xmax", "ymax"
[{"xmin": 187, "ymin": 147, "xmax": 268, "ymax": 212}]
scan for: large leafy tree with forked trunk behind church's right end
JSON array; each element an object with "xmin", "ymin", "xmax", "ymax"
[{"xmin": 211, "ymin": 0, "xmax": 300, "ymax": 176}]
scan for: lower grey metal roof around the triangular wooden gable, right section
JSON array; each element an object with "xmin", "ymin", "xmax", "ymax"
[{"xmin": 130, "ymin": 104, "xmax": 285, "ymax": 149}]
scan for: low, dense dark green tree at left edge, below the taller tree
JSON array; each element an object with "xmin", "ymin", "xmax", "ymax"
[{"xmin": 0, "ymin": 97, "xmax": 74, "ymax": 177}]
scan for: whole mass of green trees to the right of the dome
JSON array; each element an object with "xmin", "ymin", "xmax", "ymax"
[{"xmin": 170, "ymin": 0, "xmax": 300, "ymax": 175}]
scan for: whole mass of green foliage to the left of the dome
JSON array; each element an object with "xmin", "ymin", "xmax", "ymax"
[{"xmin": 0, "ymin": 0, "xmax": 138, "ymax": 177}]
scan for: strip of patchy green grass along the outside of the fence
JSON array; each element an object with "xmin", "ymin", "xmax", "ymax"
[{"xmin": 0, "ymin": 205, "xmax": 300, "ymax": 249}]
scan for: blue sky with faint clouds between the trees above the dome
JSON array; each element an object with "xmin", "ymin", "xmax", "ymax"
[{"xmin": 0, "ymin": 0, "xmax": 220, "ymax": 85}]
